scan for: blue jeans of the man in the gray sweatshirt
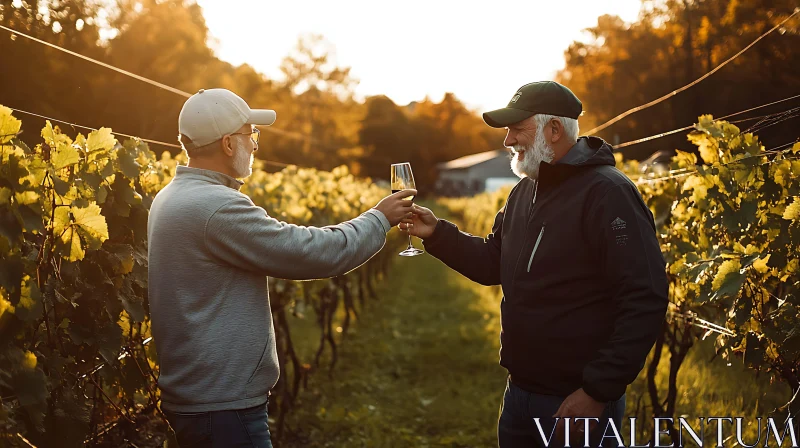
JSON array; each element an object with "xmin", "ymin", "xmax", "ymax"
[{"xmin": 162, "ymin": 403, "xmax": 272, "ymax": 448}]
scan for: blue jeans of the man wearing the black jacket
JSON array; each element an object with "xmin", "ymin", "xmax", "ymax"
[{"xmin": 497, "ymin": 380, "xmax": 625, "ymax": 448}]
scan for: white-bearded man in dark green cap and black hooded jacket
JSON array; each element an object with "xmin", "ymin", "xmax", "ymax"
[{"xmin": 400, "ymin": 81, "xmax": 668, "ymax": 448}]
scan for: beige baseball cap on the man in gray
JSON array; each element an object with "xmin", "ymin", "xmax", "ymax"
[{"xmin": 178, "ymin": 89, "xmax": 277, "ymax": 148}]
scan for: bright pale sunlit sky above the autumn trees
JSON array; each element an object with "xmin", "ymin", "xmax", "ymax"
[{"xmin": 198, "ymin": 0, "xmax": 641, "ymax": 111}]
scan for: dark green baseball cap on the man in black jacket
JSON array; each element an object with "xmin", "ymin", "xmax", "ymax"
[{"xmin": 483, "ymin": 81, "xmax": 583, "ymax": 128}]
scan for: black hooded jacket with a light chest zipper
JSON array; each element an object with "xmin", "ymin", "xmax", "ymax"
[{"xmin": 424, "ymin": 137, "xmax": 669, "ymax": 402}]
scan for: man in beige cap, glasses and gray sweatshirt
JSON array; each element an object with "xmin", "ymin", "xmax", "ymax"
[{"xmin": 147, "ymin": 89, "xmax": 416, "ymax": 447}]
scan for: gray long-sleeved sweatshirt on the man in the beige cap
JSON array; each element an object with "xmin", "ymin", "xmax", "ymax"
[{"xmin": 147, "ymin": 166, "xmax": 391, "ymax": 412}]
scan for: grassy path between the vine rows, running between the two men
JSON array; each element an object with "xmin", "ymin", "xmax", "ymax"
[{"xmin": 282, "ymin": 229, "xmax": 505, "ymax": 448}]
